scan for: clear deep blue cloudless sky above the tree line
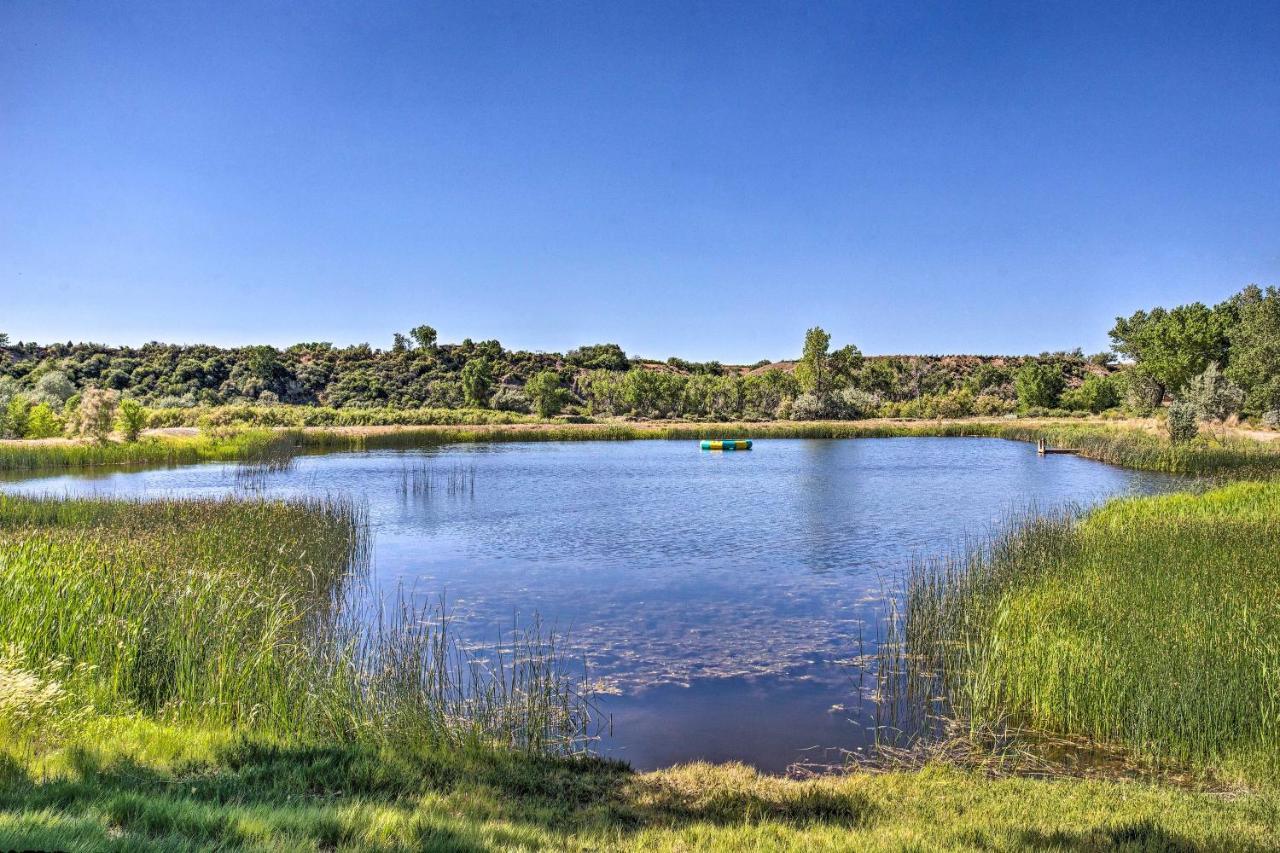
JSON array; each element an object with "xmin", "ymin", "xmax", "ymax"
[{"xmin": 0, "ymin": 0, "xmax": 1280, "ymax": 361}]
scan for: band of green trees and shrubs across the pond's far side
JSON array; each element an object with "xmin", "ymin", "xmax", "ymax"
[{"xmin": 0, "ymin": 286, "xmax": 1280, "ymax": 437}]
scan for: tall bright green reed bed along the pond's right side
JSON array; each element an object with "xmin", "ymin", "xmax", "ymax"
[{"xmin": 905, "ymin": 480, "xmax": 1280, "ymax": 785}]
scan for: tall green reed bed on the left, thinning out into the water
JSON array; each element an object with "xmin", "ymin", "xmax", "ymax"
[{"xmin": 0, "ymin": 497, "xmax": 589, "ymax": 752}]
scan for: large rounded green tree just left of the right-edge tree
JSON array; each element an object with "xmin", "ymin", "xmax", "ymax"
[{"xmin": 1111, "ymin": 302, "xmax": 1231, "ymax": 392}]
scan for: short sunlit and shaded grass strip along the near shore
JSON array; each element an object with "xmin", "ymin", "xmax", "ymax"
[{"xmin": 0, "ymin": 719, "xmax": 1280, "ymax": 850}]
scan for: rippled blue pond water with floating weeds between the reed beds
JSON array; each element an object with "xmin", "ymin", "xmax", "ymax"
[{"xmin": 3, "ymin": 438, "xmax": 1175, "ymax": 771}]
